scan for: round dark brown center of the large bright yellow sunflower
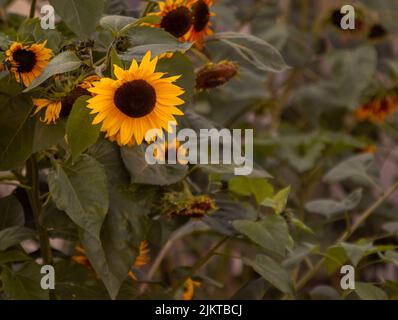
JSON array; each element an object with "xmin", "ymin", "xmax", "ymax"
[{"xmin": 114, "ymin": 80, "xmax": 156, "ymax": 118}]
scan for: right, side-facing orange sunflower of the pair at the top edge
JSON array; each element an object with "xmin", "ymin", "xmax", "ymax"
[{"xmin": 184, "ymin": 0, "xmax": 215, "ymax": 49}]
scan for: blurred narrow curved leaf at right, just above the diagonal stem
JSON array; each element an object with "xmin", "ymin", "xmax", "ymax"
[{"xmin": 305, "ymin": 189, "xmax": 362, "ymax": 219}]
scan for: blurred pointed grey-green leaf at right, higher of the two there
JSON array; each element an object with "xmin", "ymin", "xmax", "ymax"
[{"xmin": 323, "ymin": 154, "xmax": 376, "ymax": 186}]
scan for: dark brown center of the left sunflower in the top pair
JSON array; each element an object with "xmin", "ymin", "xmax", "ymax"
[{"xmin": 160, "ymin": 6, "xmax": 192, "ymax": 38}]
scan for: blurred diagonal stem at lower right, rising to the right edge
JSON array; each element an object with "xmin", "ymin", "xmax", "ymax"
[{"xmin": 290, "ymin": 181, "xmax": 398, "ymax": 296}]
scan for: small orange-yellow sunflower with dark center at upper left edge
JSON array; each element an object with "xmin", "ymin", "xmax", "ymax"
[{"xmin": 6, "ymin": 41, "xmax": 52, "ymax": 87}]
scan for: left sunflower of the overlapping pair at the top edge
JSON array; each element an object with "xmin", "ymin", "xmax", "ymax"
[{"xmin": 153, "ymin": 0, "xmax": 193, "ymax": 40}]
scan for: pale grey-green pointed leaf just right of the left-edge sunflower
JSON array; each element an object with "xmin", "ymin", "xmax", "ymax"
[{"xmin": 24, "ymin": 51, "xmax": 82, "ymax": 92}]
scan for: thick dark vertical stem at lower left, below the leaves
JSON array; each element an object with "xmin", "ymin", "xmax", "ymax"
[{"xmin": 26, "ymin": 154, "xmax": 53, "ymax": 265}]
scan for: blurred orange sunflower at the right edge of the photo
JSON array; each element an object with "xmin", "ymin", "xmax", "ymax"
[{"xmin": 355, "ymin": 96, "xmax": 398, "ymax": 122}]
